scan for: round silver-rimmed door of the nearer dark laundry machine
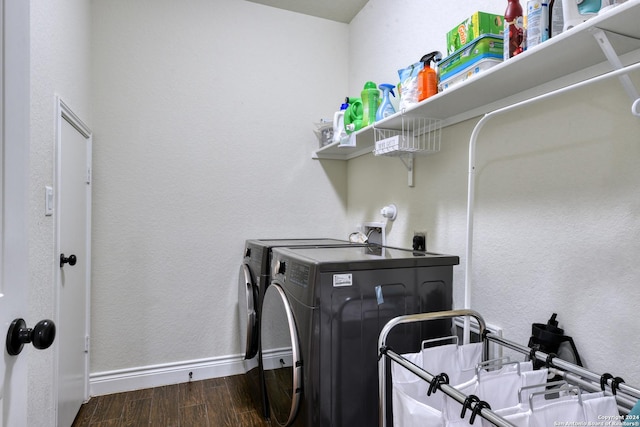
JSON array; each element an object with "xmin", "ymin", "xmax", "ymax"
[{"xmin": 260, "ymin": 283, "xmax": 302, "ymax": 426}]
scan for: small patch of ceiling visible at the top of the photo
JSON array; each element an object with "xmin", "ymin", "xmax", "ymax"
[{"xmin": 248, "ymin": 0, "xmax": 369, "ymax": 24}]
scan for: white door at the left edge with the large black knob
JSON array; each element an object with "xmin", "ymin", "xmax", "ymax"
[{"xmin": 0, "ymin": 0, "xmax": 33, "ymax": 427}]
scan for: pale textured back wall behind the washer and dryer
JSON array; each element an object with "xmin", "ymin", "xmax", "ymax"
[{"xmin": 91, "ymin": 0, "xmax": 348, "ymax": 374}]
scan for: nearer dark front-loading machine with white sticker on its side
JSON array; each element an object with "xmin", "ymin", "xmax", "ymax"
[{"xmin": 261, "ymin": 246, "xmax": 459, "ymax": 427}]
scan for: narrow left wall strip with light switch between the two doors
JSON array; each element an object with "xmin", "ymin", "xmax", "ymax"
[{"xmin": 29, "ymin": 0, "xmax": 91, "ymax": 426}]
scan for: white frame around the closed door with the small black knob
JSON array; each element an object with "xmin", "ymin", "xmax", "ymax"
[{"xmin": 53, "ymin": 96, "xmax": 93, "ymax": 419}]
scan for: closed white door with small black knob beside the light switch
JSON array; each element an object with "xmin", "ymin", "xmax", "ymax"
[{"xmin": 56, "ymin": 100, "xmax": 91, "ymax": 427}]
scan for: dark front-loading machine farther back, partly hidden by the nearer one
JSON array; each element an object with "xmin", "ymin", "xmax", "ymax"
[{"xmin": 238, "ymin": 238, "xmax": 362, "ymax": 418}]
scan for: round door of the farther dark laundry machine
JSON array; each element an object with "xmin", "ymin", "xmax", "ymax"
[{"xmin": 238, "ymin": 264, "xmax": 260, "ymax": 360}]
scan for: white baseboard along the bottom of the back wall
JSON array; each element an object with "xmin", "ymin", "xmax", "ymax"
[{"xmin": 89, "ymin": 355, "xmax": 257, "ymax": 396}]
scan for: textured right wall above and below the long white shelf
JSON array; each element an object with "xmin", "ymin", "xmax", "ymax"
[{"xmin": 348, "ymin": 0, "xmax": 640, "ymax": 386}]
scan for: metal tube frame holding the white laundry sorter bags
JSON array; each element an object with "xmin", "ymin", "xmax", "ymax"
[{"xmin": 378, "ymin": 309, "xmax": 640, "ymax": 427}]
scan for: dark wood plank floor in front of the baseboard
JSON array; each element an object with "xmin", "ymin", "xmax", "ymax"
[{"xmin": 73, "ymin": 375, "xmax": 271, "ymax": 427}]
